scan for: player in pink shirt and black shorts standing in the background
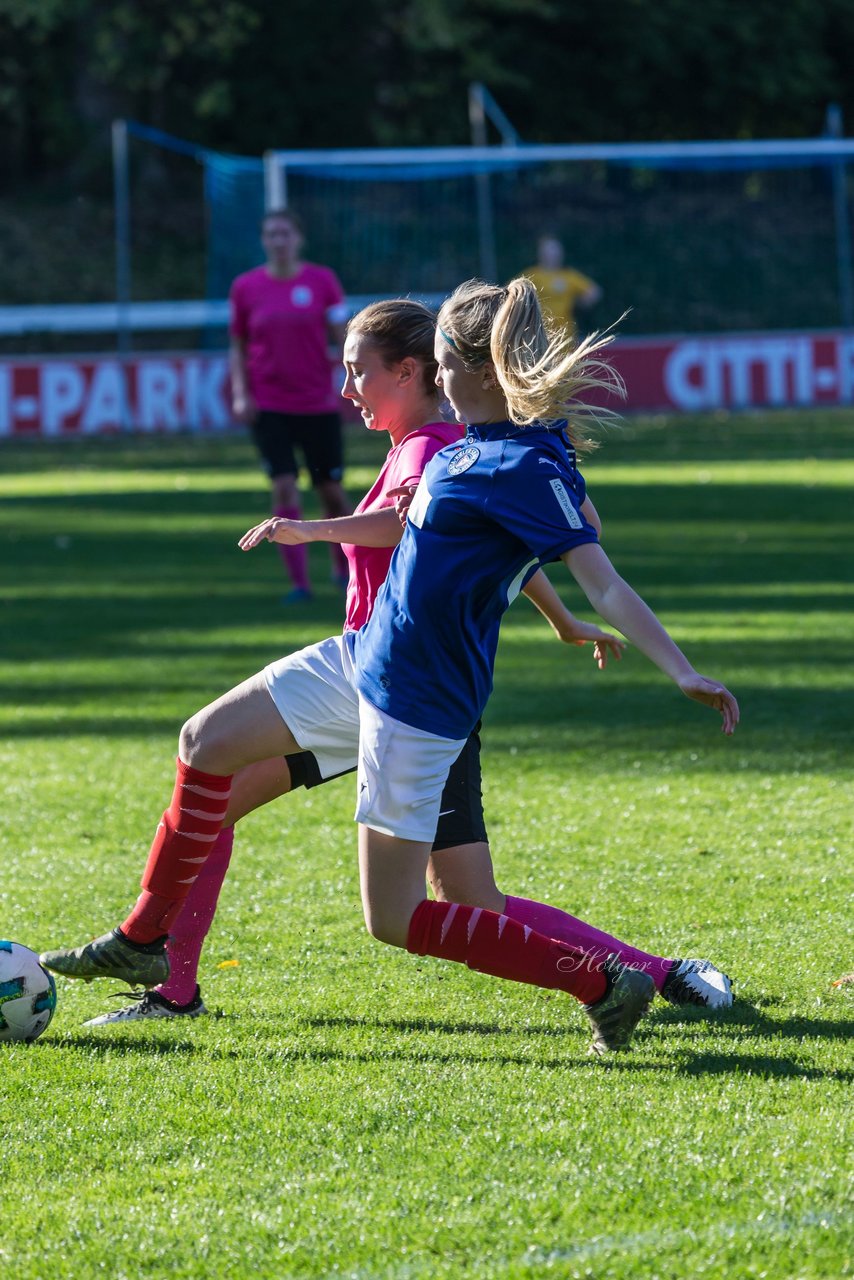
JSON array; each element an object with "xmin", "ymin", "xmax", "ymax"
[{"xmin": 229, "ymin": 209, "xmax": 350, "ymax": 603}]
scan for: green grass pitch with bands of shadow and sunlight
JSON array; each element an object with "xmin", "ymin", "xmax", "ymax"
[{"xmin": 0, "ymin": 412, "xmax": 854, "ymax": 1280}]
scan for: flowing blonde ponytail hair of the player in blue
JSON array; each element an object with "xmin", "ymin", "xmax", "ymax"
[{"xmin": 438, "ymin": 275, "xmax": 625, "ymax": 453}]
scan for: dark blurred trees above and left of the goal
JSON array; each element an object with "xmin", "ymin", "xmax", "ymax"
[{"xmin": 0, "ymin": 0, "xmax": 854, "ymax": 303}]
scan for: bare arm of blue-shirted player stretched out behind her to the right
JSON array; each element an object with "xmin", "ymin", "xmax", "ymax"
[{"xmin": 561, "ymin": 543, "xmax": 739, "ymax": 733}]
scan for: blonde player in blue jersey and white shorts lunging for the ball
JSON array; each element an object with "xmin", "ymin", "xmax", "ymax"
[{"xmin": 42, "ymin": 279, "xmax": 739, "ymax": 1053}]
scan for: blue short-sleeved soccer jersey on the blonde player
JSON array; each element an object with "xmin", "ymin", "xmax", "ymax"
[{"xmin": 350, "ymin": 422, "xmax": 597, "ymax": 739}]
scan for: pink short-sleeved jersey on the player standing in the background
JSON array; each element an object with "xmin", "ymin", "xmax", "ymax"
[{"xmin": 229, "ymin": 262, "xmax": 347, "ymax": 413}]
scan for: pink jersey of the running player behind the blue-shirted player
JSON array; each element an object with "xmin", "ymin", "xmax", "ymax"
[{"xmin": 342, "ymin": 422, "xmax": 463, "ymax": 631}]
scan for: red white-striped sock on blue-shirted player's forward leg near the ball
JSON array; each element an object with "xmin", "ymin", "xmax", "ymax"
[{"xmin": 120, "ymin": 759, "xmax": 232, "ymax": 942}]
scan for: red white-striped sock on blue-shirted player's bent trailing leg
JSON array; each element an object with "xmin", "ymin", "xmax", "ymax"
[{"xmin": 406, "ymin": 899, "xmax": 607, "ymax": 1005}]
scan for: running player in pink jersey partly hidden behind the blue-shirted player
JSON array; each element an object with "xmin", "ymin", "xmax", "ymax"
[{"xmin": 68, "ymin": 301, "xmax": 723, "ymax": 1025}]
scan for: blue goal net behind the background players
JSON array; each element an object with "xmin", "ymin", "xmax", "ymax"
[{"xmin": 123, "ymin": 125, "xmax": 854, "ymax": 334}]
